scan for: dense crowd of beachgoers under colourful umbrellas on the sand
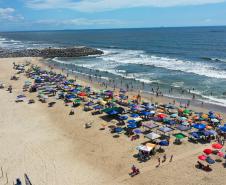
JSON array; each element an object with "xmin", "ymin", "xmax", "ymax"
[{"xmin": 0, "ymin": 62, "xmax": 226, "ymax": 184}]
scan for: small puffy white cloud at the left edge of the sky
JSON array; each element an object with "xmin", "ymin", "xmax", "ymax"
[{"xmin": 0, "ymin": 8, "xmax": 24, "ymax": 21}]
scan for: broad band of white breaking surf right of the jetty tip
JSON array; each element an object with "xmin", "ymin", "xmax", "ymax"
[{"xmin": 99, "ymin": 49, "xmax": 226, "ymax": 79}]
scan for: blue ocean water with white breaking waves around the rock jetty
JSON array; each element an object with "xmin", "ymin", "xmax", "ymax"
[{"xmin": 0, "ymin": 27, "xmax": 226, "ymax": 106}]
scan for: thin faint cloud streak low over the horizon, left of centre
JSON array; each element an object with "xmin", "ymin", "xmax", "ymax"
[{"xmin": 34, "ymin": 18, "xmax": 123, "ymax": 26}]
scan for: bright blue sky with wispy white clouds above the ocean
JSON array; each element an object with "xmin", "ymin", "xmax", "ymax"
[{"xmin": 0, "ymin": 0, "xmax": 226, "ymax": 31}]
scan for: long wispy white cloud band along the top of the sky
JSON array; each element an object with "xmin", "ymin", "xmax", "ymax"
[{"xmin": 26, "ymin": 0, "xmax": 226, "ymax": 12}]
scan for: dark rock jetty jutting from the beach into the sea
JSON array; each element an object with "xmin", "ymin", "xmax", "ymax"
[{"xmin": 0, "ymin": 47, "xmax": 103, "ymax": 58}]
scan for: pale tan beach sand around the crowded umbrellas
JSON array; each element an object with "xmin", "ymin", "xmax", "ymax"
[{"xmin": 0, "ymin": 58, "xmax": 226, "ymax": 185}]
